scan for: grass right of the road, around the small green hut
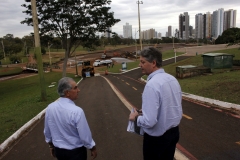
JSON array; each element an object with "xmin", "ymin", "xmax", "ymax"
[{"xmin": 164, "ymin": 48, "xmax": 240, "ymax": 104}]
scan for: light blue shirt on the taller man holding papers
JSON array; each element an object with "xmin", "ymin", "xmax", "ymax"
[{"xmin": 137, "ymin": 68, "xmax": 182, "ymax": 136}]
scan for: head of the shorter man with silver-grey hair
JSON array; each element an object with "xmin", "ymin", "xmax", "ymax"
[{"xmin": 58, "ymin": 77, "xmax": 80, "ymax": 100}]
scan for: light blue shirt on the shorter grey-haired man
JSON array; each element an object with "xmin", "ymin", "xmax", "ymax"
[{"xmin": 44, "ymin": 97, "xmax": 95, "ymax": 150}]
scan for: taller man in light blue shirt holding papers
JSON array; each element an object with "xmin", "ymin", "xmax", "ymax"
[{"xmin": 129, "ymin": 47, "xmax": 182, "ymax": 160}]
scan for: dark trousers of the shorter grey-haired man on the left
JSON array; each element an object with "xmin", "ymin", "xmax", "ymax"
[{"xmin": 55, "ymin": 147, "xmax": 87, "ymax": 160}]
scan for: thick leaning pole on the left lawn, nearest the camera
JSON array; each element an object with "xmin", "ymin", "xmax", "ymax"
[{"xmin": 31, "ymin": 0, "xmax": 47, "ymax": 101}]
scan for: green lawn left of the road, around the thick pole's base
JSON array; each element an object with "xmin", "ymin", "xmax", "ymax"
[{"xmin": 0, "ymin": 72, "xmax": 80, "ymax": 143}]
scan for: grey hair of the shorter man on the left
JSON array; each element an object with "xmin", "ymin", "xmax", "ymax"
[{"xmin": 57, "ymin": 77, "xmax": 74, "ymax": 97}]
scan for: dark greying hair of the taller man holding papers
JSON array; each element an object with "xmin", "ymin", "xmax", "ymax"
[{"xmin": 140, "ymin": 47, "xmax": 162, "ymax": 68}]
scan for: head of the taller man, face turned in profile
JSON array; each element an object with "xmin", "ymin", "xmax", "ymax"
[{"xmin": 139, "ymin": 47, "xmax": 162, "ymax": 75}]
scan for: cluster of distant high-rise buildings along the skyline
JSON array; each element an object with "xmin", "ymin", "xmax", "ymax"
[{"xmin": 120, "ymin": 8, "xmax": 237, "ymax": 40}]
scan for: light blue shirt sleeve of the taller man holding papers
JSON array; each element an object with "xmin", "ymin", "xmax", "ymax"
[{"xmin": 137, "ymin": 86, "xmax": 160, "ymax": 128}]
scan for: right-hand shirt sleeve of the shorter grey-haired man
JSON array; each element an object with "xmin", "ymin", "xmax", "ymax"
[{"xmin": 76, "ymin": 111, "xmax": 95, "ymax": 149}]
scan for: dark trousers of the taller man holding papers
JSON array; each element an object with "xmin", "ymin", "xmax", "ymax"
[{"xmin": 143, "ymin": 126, "xmax": 179, "ymax": 160}]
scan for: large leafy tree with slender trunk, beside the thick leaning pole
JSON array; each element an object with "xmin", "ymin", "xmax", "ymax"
[{"xmin": 21, "ymin": 0, "xmax": 120, "ymax": 76}]
